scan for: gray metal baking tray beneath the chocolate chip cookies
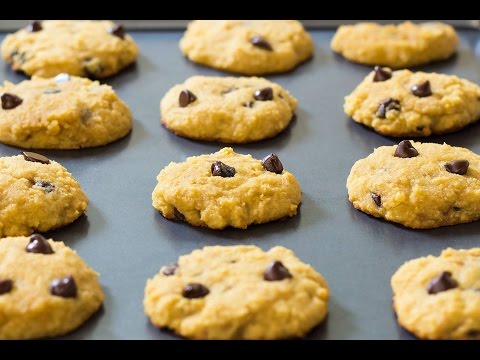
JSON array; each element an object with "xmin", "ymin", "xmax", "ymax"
[{"xmin": 0, "ymin": 26, "xmax": 480, "ymax": 339}]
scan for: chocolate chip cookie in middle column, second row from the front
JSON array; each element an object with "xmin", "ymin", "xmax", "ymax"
[{"xmin": 152, "ymin": 148, "xmax": 302, "ymax": 229}]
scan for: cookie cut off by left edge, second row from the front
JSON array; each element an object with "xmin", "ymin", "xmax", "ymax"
[{"xmin": 0, "ymin": 152, "xmax": 88, "ymax": 236}]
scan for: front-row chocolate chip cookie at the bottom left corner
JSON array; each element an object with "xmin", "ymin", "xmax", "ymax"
[{"xmin": 0, "ymin": 235, "xmax": 104, "ymax": 339}]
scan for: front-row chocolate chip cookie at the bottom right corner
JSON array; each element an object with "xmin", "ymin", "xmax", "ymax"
[{"xmin": 391, "ymin": 248, "xmax": 480, "ymax": 340}]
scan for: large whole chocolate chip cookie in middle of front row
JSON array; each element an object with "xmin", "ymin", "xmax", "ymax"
[{"xmin": 144, "ymin": 246, "xmax": 329, "ymax": 339}]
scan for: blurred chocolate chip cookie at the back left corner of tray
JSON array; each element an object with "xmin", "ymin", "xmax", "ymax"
[{"xmin": 1, "ymin": 20, "xmax": 138, "ymax": 79}]
